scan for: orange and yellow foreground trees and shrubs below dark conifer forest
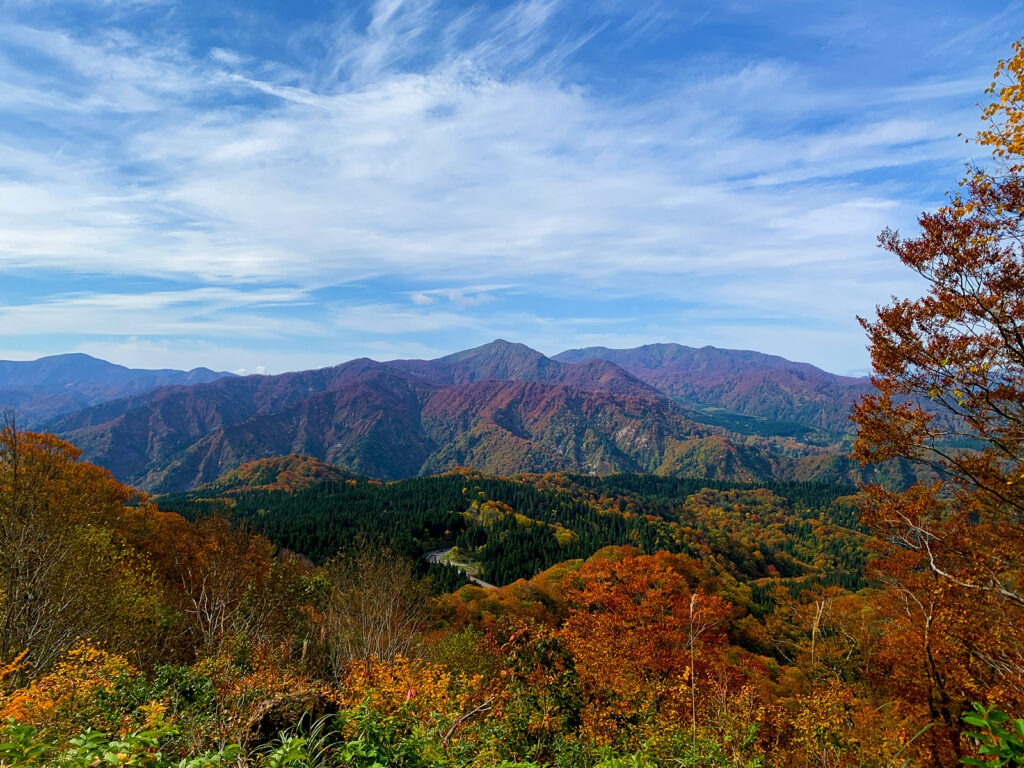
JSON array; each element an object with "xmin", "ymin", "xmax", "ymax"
[{"xmin": 0, "ymin": 417, "xmax": 991, "ymax": 766}]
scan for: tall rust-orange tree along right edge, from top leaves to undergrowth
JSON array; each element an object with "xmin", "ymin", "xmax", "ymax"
[{"xmin": 854, "ymin": 37, "xmax": 1024, "ymax": 761}]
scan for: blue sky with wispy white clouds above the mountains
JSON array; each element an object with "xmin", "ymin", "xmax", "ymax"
[{"xmin": 0, "ymin": 0, "xmax": 1024, "ymax": 375}]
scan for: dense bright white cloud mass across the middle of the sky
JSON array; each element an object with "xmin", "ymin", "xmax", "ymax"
[{"xmin": 0, "ymin": 8, "xmax": 958, "ymax": 283}]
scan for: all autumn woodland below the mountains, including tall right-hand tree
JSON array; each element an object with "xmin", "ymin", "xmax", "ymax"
[{"xmin": 6, "ymin": 46, "xmax": 1024, "ymax": 768}]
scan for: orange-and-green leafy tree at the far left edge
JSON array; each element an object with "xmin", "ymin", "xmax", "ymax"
[{"xmin": 0, "ymin": 418, "xmax": 158, "ymax": 677}]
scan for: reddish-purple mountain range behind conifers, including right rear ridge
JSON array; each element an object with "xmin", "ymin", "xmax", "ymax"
[{"xmin": 0, "ymin": 340, "xmax": 888, "ymax": 493}]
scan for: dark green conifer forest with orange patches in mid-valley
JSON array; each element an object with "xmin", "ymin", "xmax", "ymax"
[{"xmin": 158, "ymin": 462, "xmax": 864, "ymax": 587}]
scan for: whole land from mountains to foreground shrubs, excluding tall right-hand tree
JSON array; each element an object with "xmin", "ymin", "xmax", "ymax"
[{"xmin": 0, "ymin": 331, "xmax": 1015, "ymax": 768}]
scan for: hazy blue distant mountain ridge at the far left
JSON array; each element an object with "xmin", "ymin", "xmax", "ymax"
[{"xmin": 0, "ymin": 352, "xmax": 234, "ymax": 427}]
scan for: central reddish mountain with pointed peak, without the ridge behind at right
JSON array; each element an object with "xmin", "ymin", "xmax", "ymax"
[{"xmin": 53, "ymin": 341, "xmax": 823, "ymax": 492}]
